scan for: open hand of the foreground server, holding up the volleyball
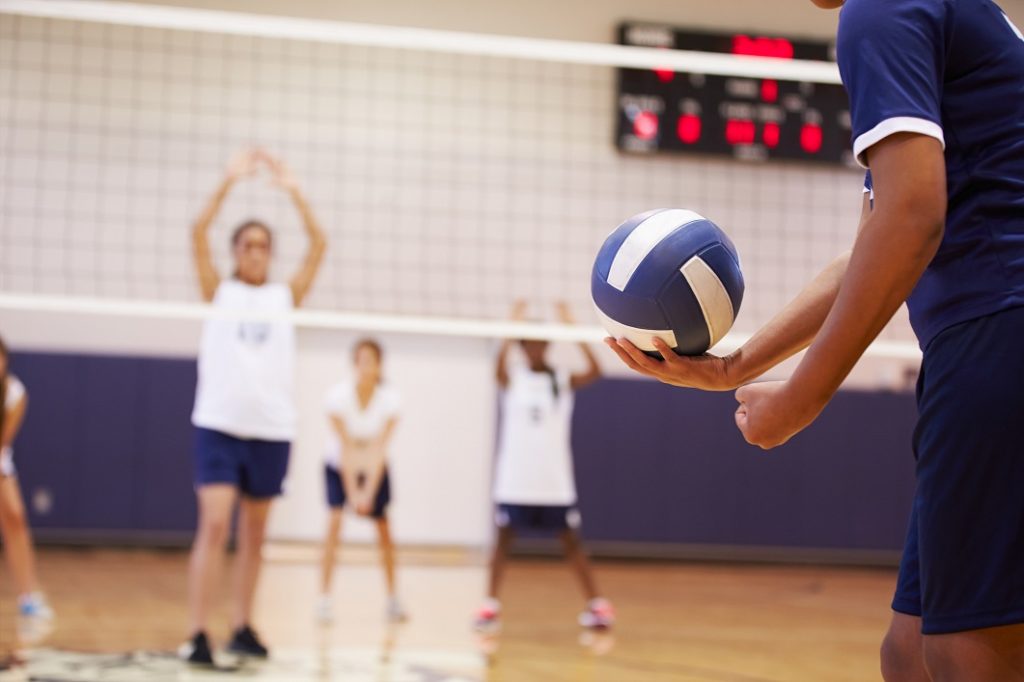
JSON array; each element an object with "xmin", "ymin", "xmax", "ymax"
[{"xmin": 604, "ymin": 338, "xmax": 739, "ymax": 391}]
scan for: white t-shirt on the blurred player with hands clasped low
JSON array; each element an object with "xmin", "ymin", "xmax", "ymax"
[{"xmin": 324, "ymin": 380, "xmax": 401, "ymax": 469}]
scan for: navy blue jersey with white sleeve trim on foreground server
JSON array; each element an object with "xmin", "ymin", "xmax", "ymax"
[{"xmin": 838, "ymin": 0, "xmax": 1024, "ymax": 348}]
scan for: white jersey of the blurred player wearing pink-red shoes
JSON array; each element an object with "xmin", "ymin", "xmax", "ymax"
[{"xmin": 495, "ymin": 367, "xmax": 577, "ymax": 506}]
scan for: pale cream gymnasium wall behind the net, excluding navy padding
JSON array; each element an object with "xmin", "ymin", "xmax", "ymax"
[{"xmin": 0, "ymin": 0, "xmax": 1007, "ymax": 546}]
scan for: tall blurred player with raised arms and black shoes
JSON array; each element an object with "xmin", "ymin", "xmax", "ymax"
[{"xmin": 182, "ymin": 151, "xmax": 327, "ymax": 666}]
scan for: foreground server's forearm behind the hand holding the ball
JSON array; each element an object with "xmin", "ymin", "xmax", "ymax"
[{"xmin": 727, "ymin": 252, "xmax": 850, "ymax": 386}]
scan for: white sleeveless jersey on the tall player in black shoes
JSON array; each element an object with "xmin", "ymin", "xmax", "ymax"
[{"xmin": 193, "ymin": 280, "xmax": 295, "ymax": 440}]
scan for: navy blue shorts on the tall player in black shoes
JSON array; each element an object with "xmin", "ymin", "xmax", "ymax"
[{"xmin": 195, "ymin": 427, "xmax": 292, "ymax": 498}]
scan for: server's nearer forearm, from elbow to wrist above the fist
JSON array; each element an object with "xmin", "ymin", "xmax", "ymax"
[{"xmin": 791, "ymin": 209, "xmax": 943, "ymax": 407}]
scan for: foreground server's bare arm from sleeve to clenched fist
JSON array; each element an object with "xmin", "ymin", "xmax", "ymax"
[{"xmin": 736, "ymin": 133, "xmax": 946, "ymax": 449}]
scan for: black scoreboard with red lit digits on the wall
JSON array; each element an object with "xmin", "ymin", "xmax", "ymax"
[{"xmin": 615, "ymin": 23, "xmax": 854, "ymax": 166}]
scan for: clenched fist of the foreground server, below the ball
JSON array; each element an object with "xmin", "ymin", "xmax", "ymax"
[{"xmin": 736, "ymin": 381, "xmax": 824, "ymax": 450}]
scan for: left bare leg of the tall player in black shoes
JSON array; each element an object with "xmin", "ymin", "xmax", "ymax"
[{"xmin": 188, "ymin": 483, "xmax": 238, "ymax": 633}]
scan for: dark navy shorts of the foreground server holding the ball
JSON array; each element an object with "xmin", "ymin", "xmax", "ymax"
[{"xmin": 893, "ymin": 308, "xmax": 1024, "ymax": 635}]
